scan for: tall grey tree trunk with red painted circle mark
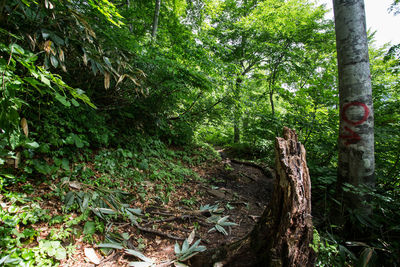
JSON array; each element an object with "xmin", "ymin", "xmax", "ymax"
[{"xmin": 333, "ymin": 0, "xmax": 375, "ymax": 210}]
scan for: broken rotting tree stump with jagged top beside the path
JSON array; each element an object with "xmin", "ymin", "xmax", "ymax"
[{"xmin": 191, "ymin": 127, "xmax": 315, "ymax": 267}]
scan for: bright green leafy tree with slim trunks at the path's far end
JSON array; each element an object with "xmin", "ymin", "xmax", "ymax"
[{"xmin": 205, "ymin": 0, "xmax": 332, "ymax": 142}]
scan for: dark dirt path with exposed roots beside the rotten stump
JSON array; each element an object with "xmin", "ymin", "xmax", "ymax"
[{"xmin": 61, "ymin": 150, "xmax": 273, "ymax": 267}]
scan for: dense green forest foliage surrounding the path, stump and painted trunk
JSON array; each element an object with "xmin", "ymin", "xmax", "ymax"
[{"xmin": 0, "ymin": 0, "xmax": 400, "ymax": 266}]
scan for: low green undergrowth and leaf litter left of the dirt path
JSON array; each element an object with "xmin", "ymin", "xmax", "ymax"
[{"xmin": 0, "ymin": 137, "xmax": 218, "ymax": 266}]
